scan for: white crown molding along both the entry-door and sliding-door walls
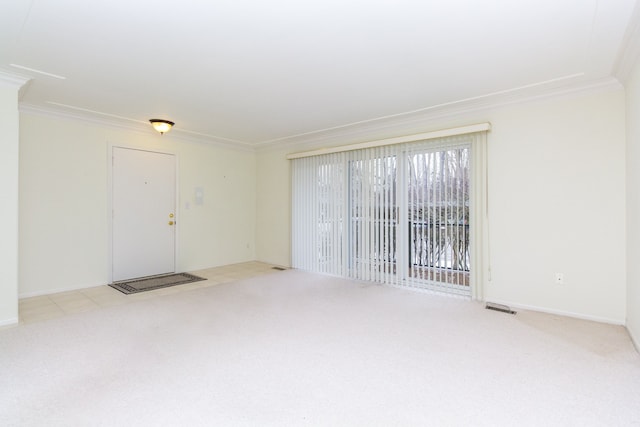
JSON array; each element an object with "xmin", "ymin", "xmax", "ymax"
[{"xmin": 16, "ymin": 72, "xmax": 623, "ymax": 156}]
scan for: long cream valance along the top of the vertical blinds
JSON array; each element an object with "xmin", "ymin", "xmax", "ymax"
[{"xmin": 287, "ymin": 123, "xmax": 491, "ymax": 160}]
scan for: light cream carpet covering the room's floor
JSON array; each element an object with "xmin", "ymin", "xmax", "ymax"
[{"xmin": 0, "ymin": 270, "xmax": 640, "ymax": 426}]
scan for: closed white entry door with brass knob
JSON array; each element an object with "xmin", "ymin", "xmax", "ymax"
[{"xmin": 112, "ymin": 147, "xmax": 176, "ymax": 282}]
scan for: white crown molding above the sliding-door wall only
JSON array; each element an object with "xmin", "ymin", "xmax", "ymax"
[{"xmin": 256, "ymin": 75, "xmax": 623, "ymax": 152}]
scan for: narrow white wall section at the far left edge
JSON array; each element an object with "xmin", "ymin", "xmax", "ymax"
[{"xmin": 0, "ymin": 81, "xmax": 20, "ymax": 326}]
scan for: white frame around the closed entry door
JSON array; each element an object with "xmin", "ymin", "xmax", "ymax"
[{"xmin": 106, "ymin": 142, "xmax": 182, "ymax": 283}]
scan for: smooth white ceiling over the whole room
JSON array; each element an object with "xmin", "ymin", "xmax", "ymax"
[{"xmin": 0, "ymin": 0, "xmax": 636, "ymax": 147}]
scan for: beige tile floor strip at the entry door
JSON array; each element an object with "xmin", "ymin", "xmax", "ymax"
[{"xmin": 19, "ymin": 261, "xmax": 279, "ymax": 324}]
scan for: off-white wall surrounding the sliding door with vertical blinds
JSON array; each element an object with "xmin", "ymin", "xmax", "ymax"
[{"xmin": 256, "ymin": 88, "xmax": 626, "ymax": 323}]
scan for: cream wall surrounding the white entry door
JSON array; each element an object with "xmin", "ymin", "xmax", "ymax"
[{"xmin": 19, "ymin": 113, "xmax": 256, "ymax": 296}]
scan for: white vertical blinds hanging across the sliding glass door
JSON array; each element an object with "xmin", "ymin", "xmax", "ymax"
[{"xmin": 292, "ymin": 132, "xmax": 485, "ymax": 296}]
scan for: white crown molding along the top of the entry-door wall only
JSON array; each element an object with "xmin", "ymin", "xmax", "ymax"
[{"xmin": 18, "ymin": 103, "xmax": 255, "ymax": 151}]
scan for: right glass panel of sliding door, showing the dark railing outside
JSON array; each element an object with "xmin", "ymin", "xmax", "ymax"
[{"xmin": 404, "ymin": 146, "xmax": 472, "ymax": 295}]
